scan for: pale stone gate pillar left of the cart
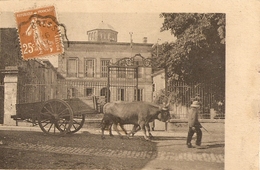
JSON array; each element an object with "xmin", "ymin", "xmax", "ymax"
[{"xmin": 3, "ymin": 66, "xmax": 18, "ymax": 126}]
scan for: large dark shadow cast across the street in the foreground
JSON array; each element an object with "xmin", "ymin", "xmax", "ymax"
[{"xmin": 0, "ymin": 130, "xmax": 158, "ymax": 170}]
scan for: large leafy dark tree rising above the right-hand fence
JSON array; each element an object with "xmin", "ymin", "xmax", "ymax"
[{"xmin": 153, "ymin": 13, "xmax": 225, "ymax": 99}]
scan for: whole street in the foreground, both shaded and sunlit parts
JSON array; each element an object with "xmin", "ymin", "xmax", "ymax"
[{"xmin": 0, "ymin": 123, "xmax": 224, "ymax": 170}]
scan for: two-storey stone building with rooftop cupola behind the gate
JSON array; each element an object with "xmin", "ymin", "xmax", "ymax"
[{"xmin": 58, "ymin": 22, "xmax": 152, "ymax": 101}]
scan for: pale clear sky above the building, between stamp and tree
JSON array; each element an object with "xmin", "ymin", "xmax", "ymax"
[{"xmin": 0, "ymin": 11, "xmax": 174, "ymax": 43}]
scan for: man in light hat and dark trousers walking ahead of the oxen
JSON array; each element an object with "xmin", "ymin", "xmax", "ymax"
[{"xmin": 187, "ymin": 101, "xmax": 202, "ymax": 148}]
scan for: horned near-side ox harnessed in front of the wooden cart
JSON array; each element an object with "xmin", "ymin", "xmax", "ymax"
[{"xmin": 101, "ymin": 102, "xmax": 170, "ymax": 140}]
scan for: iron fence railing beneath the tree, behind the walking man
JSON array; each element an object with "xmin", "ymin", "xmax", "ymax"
[{"xmin": 167, "ymin": 81, "xmax": 225, "ymax": 119}]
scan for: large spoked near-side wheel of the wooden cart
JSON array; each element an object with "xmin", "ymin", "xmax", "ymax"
[{"xmin": 38, "ymin": 99, "xmax": 73, "ymax": 135}]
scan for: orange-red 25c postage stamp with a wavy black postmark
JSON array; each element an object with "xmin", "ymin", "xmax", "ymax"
[{"xmin": 15, "ymin": 6, "xmax": 63, "ymax": 59}]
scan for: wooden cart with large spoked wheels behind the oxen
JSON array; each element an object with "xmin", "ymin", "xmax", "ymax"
[{"xmin": 11, "ymin": 97, "xmax": 97, "ymax": 135}]
